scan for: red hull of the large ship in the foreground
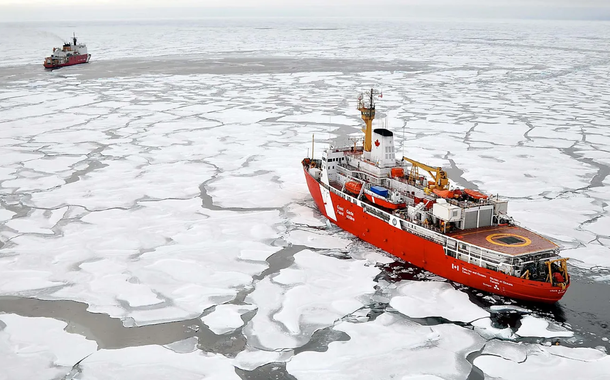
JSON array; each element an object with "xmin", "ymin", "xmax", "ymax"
[{"xmin": 304, "ymin": 167, "xmax": 567, "ymax": 303}]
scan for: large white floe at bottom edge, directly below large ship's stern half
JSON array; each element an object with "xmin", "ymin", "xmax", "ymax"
[{"xmin": 286, "ymin": 312, "xmax": 484, "ymax": 380}]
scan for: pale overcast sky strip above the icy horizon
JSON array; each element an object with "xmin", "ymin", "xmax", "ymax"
[{"xmin": 0, "ymin": 0, "xmax": 610, "ymax": 21}]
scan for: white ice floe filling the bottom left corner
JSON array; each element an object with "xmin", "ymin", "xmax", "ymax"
[{"xmin": 0, "ymin": 314, "xmax": 97, "ymax": 380}]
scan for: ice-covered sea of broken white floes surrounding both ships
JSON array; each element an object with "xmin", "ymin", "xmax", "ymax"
[{"xmin": 0, "ymin": 19, "xmax": 610, "ymax": 380}]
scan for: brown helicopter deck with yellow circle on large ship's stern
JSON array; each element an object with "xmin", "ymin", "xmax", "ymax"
[{"xmin": 447, "ymin": 226, "xmax": 557, "ymax": 256}]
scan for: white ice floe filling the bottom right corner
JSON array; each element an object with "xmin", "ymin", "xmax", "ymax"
[{"xmin": 474, "ymin": 342, "xmax": 610, "ymax": 380}]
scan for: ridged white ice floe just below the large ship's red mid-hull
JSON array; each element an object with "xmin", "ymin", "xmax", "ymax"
[{"xmin": 244, "ymin": 250, "xmax": 379, "ymax": 350}]
